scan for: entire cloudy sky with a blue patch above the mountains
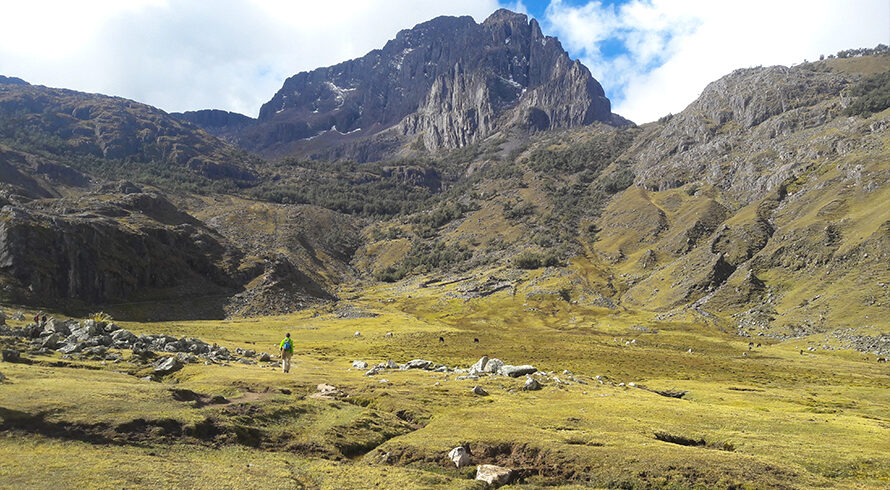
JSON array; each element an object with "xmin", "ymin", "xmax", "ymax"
[{"xmin": 0, "ymin": 0, "xmax": 890, "ymax": 123}]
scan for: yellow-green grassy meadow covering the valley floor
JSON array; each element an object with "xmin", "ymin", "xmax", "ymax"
[{"xmin": 0, "ymin": 285, "xmax": 890, "ymax": 488}]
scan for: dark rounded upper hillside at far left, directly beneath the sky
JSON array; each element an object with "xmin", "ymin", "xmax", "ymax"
[{"xmin": 0, "ymin": 84, "xmax": 256, "ymax": 180}]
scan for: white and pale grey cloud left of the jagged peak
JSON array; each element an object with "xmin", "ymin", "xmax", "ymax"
[{"xmin": 0, "ymin": 0, "xmax": 500, "ymax": 115}]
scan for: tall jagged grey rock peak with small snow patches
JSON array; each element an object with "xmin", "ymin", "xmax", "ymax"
[{"xmin": 232, "ymin": 10, "xmax": 616, "ymax": 154}]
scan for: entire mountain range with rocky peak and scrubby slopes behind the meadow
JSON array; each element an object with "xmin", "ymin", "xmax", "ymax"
[{"xmin": 0, "ymin": 11, "xmax": 890, "ymax": 338}]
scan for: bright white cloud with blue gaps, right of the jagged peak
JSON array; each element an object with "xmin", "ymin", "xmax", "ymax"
[{"xmin": 543, "ymin": 0, "xmax": 890, "ymax": 122}]
